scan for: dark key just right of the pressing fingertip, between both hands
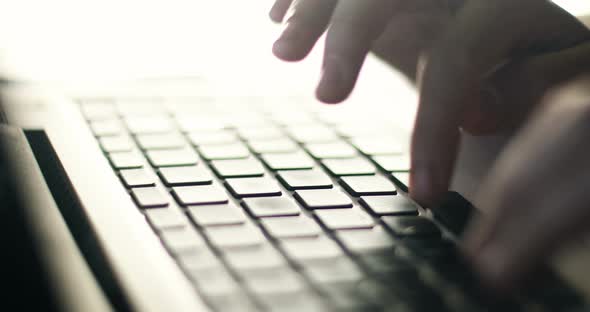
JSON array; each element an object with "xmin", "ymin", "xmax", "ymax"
[{"xmin": 431, "ymin": 192, "xmax": 477, "ymax": 235}]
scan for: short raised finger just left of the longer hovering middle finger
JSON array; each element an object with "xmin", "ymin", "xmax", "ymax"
[{"xmin": 273, "ymin": 0, "xmax": 337, "ymax": 61}]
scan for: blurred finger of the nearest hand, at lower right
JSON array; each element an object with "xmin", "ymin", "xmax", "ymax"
[{"xmin": 466, "ymin": 78, "xmax": 590, "ymax": 289}]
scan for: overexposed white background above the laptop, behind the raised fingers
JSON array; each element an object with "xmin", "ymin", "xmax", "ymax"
[{"xmin": 0, "ymin": 0, "xmax": 590, "ymax": 127}]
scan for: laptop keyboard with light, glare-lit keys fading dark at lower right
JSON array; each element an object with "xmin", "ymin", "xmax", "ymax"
[{"xmin": 80, "ymin": 98, "xmax": 582, "ymax": 311}]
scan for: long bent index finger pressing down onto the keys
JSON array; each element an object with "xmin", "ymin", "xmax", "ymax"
[{"xmin": 410, "ymin": 0, "xmax": 587, "ymax": 206}]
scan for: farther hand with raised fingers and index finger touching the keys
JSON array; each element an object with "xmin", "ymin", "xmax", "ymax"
[{"xmin": 270, "ymin": 0, "xmax": 590, "ymax": 206}]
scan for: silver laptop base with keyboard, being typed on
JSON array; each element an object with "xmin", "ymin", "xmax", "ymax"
[{"xmin": 0, "ymin": 2, "xmax": 590, "ymax": 312}]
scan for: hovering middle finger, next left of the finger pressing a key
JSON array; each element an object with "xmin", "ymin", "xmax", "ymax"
[{"xmin": 316, "ymin": 0, "xmax": 396, "ymax": 103}]
